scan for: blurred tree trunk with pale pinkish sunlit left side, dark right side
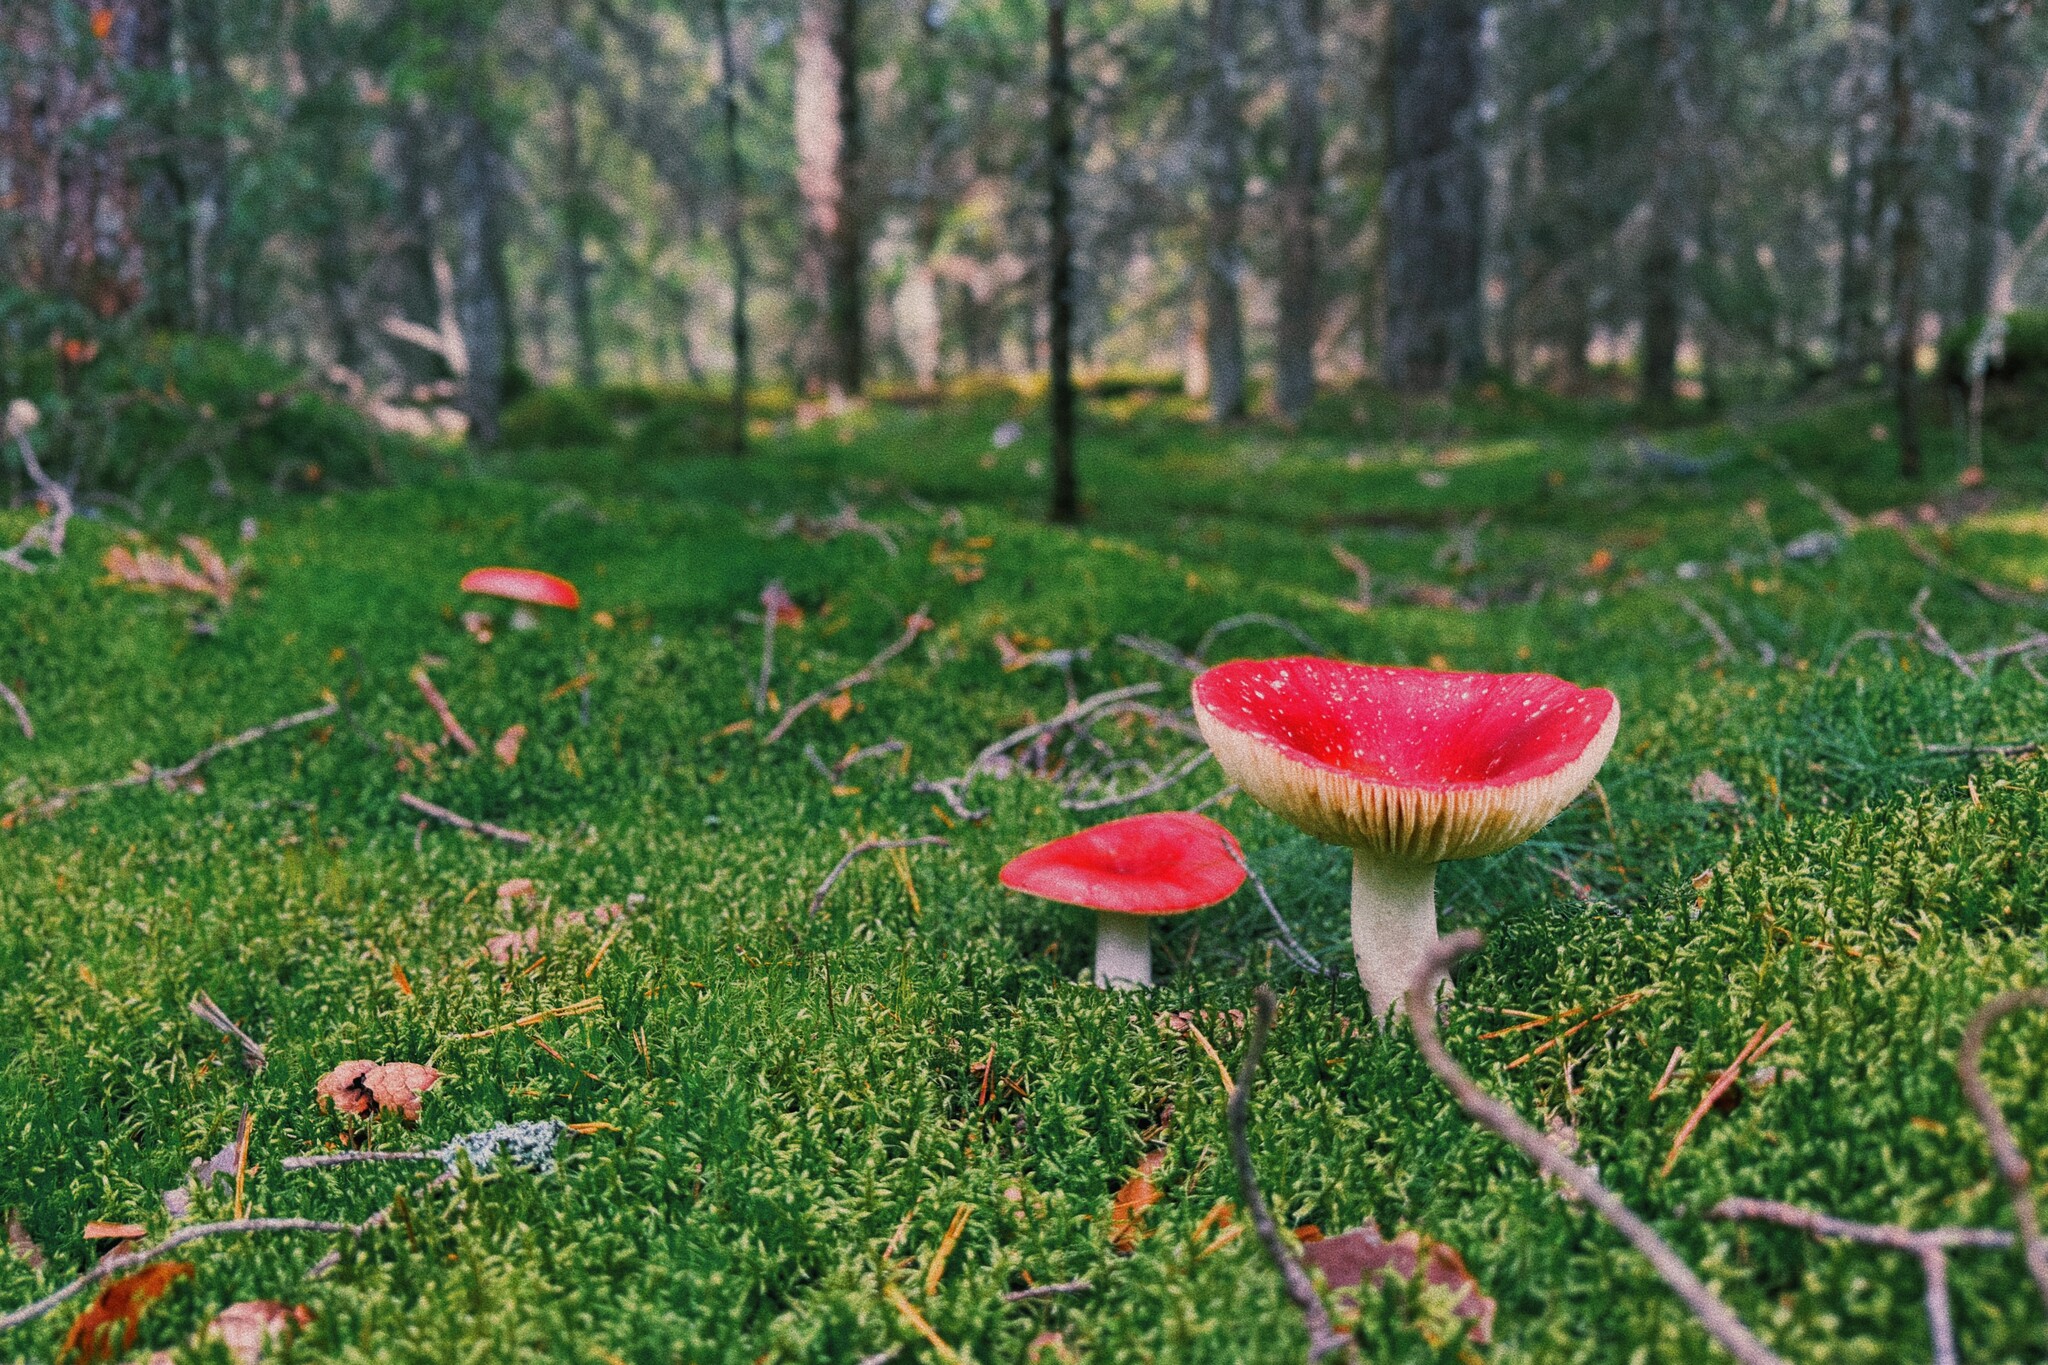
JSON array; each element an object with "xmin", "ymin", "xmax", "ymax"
[{"xmin": 797, "ymin": 0, "xmax": 866, "ymax": 397}]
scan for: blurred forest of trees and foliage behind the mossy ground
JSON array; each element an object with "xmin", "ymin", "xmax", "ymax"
[{"xmin": 12, "ymin": 0, "xmax": 2048, "ymax": 497}]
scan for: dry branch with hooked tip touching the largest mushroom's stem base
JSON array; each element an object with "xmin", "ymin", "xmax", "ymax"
[{"xmin": 1400, "ymin": 929, "xmax": 1782, "ymax": 1365}]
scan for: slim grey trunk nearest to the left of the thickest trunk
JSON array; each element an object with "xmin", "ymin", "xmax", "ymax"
[{"xmin": 1274, "ymin": 0, "xmax": 1323, "ymax": 422}]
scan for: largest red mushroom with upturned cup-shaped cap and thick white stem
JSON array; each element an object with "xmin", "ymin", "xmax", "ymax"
[{"xmin": 1194, "ymin": 659, "xmax": 1622, "ymax": 1015}]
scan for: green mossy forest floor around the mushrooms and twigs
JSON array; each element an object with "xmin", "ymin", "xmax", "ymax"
[{"xmin": 0, "ymin": 384, "xmax": 2048, "ymax": 1363}]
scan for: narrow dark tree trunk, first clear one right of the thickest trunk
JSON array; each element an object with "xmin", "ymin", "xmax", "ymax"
[{"xmin": 1638, "ymin": 0, "xmax": 1698, "ymax": 413}]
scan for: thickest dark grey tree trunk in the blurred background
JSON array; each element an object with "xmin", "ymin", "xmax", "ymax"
[{"xmin": 1384, "ymin": 0, "xmax": 1485, "ymax": 391}]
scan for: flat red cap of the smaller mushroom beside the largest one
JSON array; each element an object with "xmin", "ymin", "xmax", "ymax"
[{"xmin": 1001, "ymin": 810, "xmax": 1245, "ymax": 915}]
